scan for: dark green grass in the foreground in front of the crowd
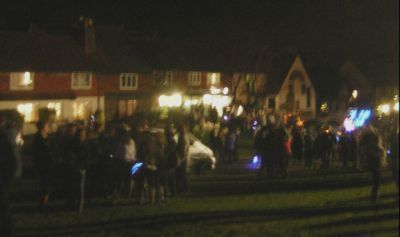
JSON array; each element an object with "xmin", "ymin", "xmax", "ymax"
[{"xmin": 13, "ymin": 170, "xmax": 399, "ymax": 236}]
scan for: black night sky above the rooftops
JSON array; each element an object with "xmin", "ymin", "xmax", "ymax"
[{"xmin": 0, "ymin": 0, "xmax": 399, "ymax": 85}]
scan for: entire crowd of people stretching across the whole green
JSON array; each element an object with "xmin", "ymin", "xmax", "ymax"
[{"xmin": 0, "ymin": 107, "xmax": 399, "ymax": 236}]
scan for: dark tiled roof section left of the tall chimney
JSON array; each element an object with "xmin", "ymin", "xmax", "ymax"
[{"xmin": 0, "ymin": 31, "xmax": 91, "ymax": 72}]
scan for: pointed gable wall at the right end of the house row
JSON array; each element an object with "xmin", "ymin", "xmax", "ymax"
[{"xmin": 275, "ymin": 57, "xmax": 316, "ymax": 116}]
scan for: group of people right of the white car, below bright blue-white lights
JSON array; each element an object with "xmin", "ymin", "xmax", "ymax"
[{"xmin": 254, "ymin": 114, "xmax": 399, "ymax": 202}]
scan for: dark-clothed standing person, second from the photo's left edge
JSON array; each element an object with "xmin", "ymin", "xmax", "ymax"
[{"xmin": 32, "ymin": 121, "xmax": 54, "ymax": 210}]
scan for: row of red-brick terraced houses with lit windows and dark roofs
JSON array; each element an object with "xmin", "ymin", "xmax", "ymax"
[{"xmin": 0, "ymin": 21, "xmax": 322, "ymax": 132}]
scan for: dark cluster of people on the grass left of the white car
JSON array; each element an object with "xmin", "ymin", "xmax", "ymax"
[{"xmin": 28, "ymin": 118, "xmax": 195, "ymax": 209}]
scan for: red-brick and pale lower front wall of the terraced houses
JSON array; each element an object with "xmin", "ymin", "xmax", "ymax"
[{"xmin": 0, "ymin": 71, "xmax": 241, "ymax": 123}]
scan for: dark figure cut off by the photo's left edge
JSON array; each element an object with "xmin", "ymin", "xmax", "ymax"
[{"xmin": 0, "ymin": 123, "xmax": 22, "ymax": 236}]
